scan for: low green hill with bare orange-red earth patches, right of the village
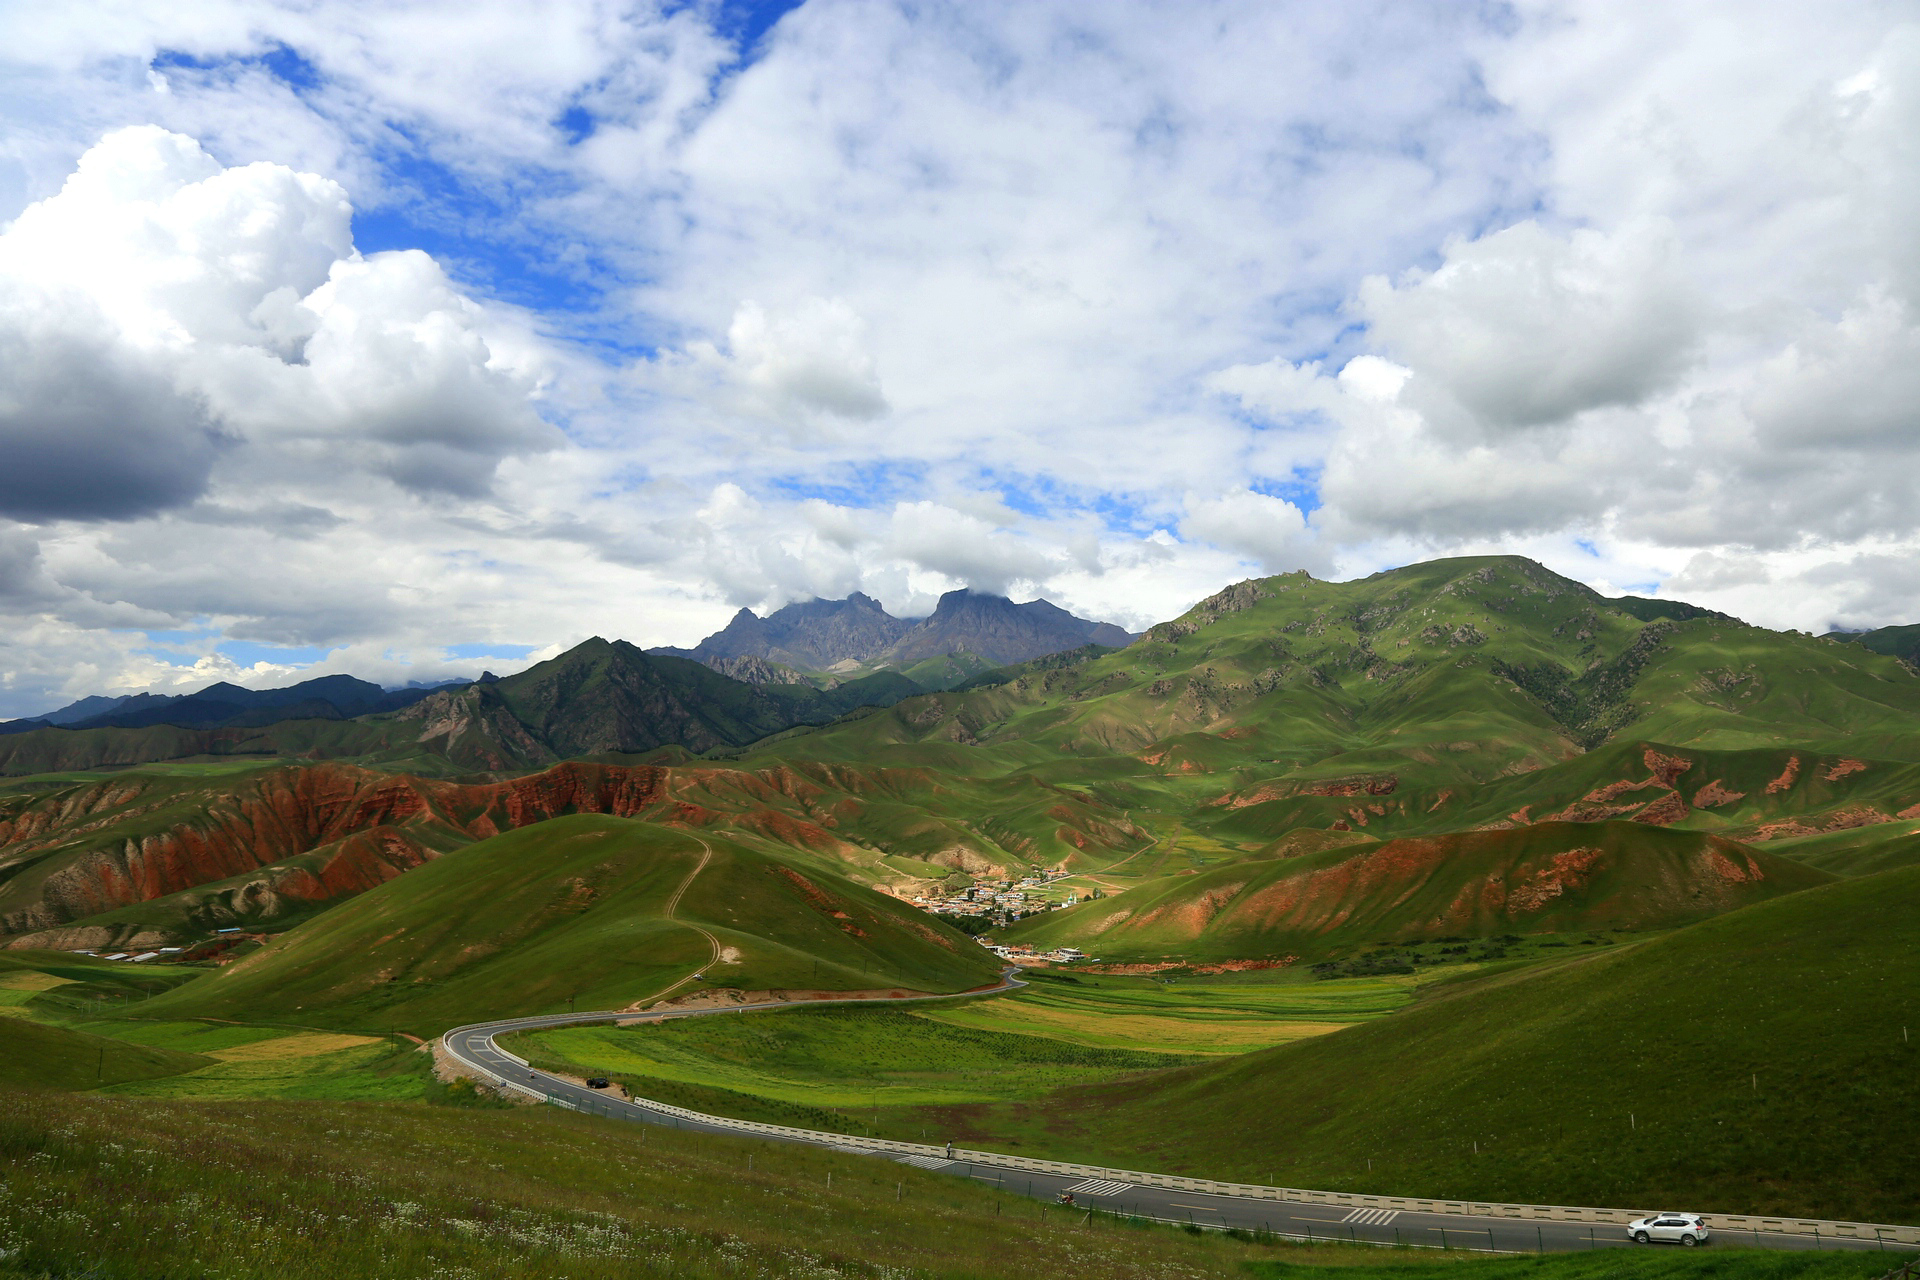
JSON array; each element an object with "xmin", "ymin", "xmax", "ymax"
[{"xmin": 1002, "ymin": 821, "xmax": 1828, "ymax": 960}]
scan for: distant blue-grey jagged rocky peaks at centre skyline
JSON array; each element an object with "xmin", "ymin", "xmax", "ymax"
[{"xmin": 647, "ymin": 591, "xmax": 1139, "ymax": 687}]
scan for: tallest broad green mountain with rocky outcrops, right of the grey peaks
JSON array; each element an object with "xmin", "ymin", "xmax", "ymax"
[{"xmin": 760, "ymin": 557, "xmax": 1920, "ymax": 785}]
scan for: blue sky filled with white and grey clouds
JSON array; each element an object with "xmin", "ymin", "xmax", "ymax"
[{"xmin": 0, "ymin": 0, "xmax": 1920, "ymax": 716}]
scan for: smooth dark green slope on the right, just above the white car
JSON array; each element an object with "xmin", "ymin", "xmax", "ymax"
[{"xmin": 975, "ymin": 867, "xmax": 1920, "ymax": 1222}]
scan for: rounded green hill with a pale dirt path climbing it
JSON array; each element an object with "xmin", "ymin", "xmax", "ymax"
[{"xmin": 148, "ymin": 814, "xmax": 998, "ymax": 1036}]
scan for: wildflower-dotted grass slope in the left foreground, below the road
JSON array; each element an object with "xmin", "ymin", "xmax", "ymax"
[{"xmin": 0, "ymin": 1094, "xmax": 1313, "ymax": 1280}]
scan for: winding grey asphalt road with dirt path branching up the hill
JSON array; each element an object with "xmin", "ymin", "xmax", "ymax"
[{"xmin": 442, "ymin": 841, "xmax": 1912, "ymax": 1253}]
